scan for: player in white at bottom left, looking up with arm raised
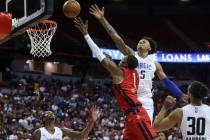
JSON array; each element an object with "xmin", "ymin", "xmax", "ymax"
[{"xmin": 32, "ymin": 106, "xmax": 99, "ymax": 140}]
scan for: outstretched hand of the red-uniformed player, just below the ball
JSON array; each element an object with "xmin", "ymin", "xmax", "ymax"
[{"xmin": 74, "ymin": 17, "xmax": 88, "ymax": 35}]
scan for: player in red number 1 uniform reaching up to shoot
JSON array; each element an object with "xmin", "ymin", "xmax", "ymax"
[{"xmin": 74, "ymin": 18, "xmax": 157, "ymax": 140}]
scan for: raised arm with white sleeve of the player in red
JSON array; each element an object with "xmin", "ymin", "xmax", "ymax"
[{"xmin": 74, "ymin": 18, "xmax": 123, "ymax": 77}]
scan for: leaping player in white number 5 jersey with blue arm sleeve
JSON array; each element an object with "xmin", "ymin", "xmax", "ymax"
[{"xmin": 90, "ymin": 4, "xmax": 187, "ymax": 121}]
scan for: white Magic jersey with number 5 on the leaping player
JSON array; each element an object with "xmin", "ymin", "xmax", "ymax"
[{"xmin": 135, "ymin": 52, "xmax": 156, "ymax": 97}]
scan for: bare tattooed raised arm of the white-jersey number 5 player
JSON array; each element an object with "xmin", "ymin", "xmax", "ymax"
[{"xmin": 89, "ymin": 4, "xmax": 134, "ymax": 55}]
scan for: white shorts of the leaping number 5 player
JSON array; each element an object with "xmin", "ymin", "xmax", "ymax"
[{"xmin": 138, "ymin": 96, "xmax": 154, "ymax": 123}]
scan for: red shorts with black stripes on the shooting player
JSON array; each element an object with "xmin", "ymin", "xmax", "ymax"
[{"xmin": 123, "ymin": 107, "xmax": 157, "ymax": 140}]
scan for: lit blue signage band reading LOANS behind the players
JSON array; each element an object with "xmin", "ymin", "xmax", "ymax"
[{"xmin": 93, "ymin": 49, "xmax": 210, "ymax": 63}]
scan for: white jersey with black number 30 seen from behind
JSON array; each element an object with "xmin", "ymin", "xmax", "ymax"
[{"xmin": 180, "ymin": 104, "xmax": 210, "ymax": 140}]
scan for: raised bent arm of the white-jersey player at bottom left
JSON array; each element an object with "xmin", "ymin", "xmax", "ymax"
[{"xmin": 62, "ymin": 106, "xmax": 99, "ymax": 140}]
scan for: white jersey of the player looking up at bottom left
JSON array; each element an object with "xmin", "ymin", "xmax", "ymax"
[{"xmin": 39, "ymin": 127, "xmax": 63, "ymax": 140}]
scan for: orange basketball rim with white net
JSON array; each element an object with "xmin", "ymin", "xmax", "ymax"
[{"xmin": 27, "ymin": 20, "xmax": 57, "ymax": 57}]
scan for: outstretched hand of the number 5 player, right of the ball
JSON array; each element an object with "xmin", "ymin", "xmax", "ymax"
[{"xmin": 89, "ymin": 4, "xmax": 104, "ymax": 20}]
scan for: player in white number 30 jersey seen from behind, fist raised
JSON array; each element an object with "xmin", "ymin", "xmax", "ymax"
[{"xmin": 153, "ymin": 81, "xmax": 210, "ymax": 140}]
